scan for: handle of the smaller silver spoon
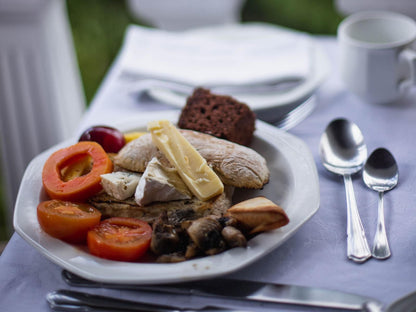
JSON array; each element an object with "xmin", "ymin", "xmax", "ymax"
[{"xmin": 372, "ymin": 192, "xmax": 391, "ymax": 259}]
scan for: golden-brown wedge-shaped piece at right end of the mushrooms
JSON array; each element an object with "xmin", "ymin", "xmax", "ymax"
[{"xmin": 225, "ymin": 197, "xmax": 289, "ymax": 234}]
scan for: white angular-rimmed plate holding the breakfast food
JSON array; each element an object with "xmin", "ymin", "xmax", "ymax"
[{"xmin": 14, "ymin": 112, "xmax": 319, "ymax": 284}]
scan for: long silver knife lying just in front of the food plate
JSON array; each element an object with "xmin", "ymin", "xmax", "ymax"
[{"xmin": 62, "ymin": 270, "xmax": 381, "ymax": 311}]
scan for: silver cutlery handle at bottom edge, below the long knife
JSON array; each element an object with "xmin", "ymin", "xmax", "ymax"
[{"xmin": 46, "ymin": 289, "xmax": 248, "ymax": 312}]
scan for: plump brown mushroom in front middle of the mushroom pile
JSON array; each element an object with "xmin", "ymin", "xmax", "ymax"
[{"xmin": 187, "ymin": 216, "xmax": 226, "ymax": 255}]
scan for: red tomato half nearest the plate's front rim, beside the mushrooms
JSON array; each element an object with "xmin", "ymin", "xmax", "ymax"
[{"xmin": 87, "ymin": 218, "xmax": 152, "ymax": 261}]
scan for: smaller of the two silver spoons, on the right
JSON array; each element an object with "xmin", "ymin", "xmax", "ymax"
[{"xmin": 363, "ymin": 148, "xmax": 399, "ymax": 259}]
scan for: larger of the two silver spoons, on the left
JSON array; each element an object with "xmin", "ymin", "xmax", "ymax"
[{"xmin": 319, "ymin": 119, "xmax": 371, "ymax": 262}]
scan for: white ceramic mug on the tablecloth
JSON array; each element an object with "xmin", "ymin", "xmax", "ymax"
[{"xmin": 338, "ymin": 11, "xmax": 416, "ymax": 104}]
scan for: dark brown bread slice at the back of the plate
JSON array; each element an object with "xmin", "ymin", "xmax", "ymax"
[{"xmin": 178, "ymin": 88, "xmax": 256, "ymax": 146}]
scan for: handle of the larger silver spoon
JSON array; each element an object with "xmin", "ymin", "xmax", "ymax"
[{"xmin": 344, "ymin": 174, "xmax": 371, "ymax": 262}]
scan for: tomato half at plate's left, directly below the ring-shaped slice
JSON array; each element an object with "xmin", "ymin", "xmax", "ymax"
[{"xmin": 37, "ymin": 199, "xmax": 101, "ymax": 243}]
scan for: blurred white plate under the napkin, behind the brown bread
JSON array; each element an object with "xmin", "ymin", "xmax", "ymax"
[{"xmin": 148, "ymin": 43, "xmax": 329, "ymax": 122}]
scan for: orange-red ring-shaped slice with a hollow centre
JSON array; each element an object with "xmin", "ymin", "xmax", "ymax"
[{"xmin": 42, "ymin": 141, "xmax": 113, "ymax": 202}]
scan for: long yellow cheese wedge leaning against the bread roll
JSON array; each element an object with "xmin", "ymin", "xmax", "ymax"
[{"xmin": 147, "ymin": 120, "xmax": 224, "ymax": 201}]
